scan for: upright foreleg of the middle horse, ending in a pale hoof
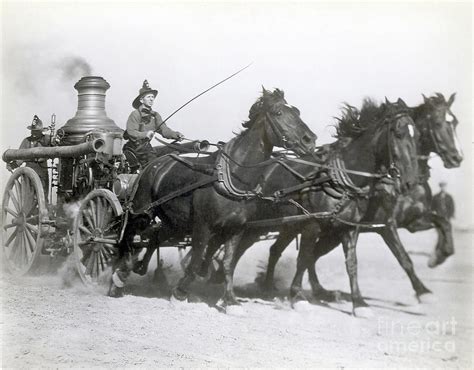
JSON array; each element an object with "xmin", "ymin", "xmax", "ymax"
[{"xmin": 342, "ymin": 228, "xmax": 372, "ymax": 317}]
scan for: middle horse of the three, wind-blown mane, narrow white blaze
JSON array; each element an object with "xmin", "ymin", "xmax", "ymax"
[{"xmin": 198, "ymin": 100, "xmax": 417, "ymax": 308}]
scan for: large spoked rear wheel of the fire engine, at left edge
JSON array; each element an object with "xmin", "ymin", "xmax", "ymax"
[{"xmin": 2, "ymin": 167, "xmax": 48, "ymax": 276}]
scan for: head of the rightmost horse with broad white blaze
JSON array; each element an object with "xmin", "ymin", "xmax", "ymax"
[{"xmin": 415, "ymin": 93, "xmax": 463, "ymax": 168}]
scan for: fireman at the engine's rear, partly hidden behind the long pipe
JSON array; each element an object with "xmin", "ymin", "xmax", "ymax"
[{"xmin": 7, "ymin": 115, "xmax": 51, "ymax": 197}]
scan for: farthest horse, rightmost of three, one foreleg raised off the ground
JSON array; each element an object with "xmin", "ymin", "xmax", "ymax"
[{"xmin": 262, "ymin": 93, "xmax": 462, "ymax": 312}]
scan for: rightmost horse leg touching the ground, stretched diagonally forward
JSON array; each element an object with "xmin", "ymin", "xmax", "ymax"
[{"xmin": 379, "ymin": 225, "xmax": 431, "ymax": 299}]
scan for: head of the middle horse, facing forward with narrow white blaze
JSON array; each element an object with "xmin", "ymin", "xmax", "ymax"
[{"xmin": 375, "ymin": 99, "xmax": 418, "ymax": 191}]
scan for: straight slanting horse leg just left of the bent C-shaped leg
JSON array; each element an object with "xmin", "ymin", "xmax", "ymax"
[{"xmin": 290, "ymin": 226, "xmax": 320, "ymax": 306}]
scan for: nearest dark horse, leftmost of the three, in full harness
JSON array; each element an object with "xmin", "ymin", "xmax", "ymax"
[{"xmin": 109, "ymin": 88, "xmax": 317, "ymax": 300}]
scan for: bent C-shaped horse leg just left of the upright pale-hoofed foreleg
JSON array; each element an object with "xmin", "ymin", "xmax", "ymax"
[{"xmin": 308, "ymin": 235, "xmax": 341, "ymax": 302}]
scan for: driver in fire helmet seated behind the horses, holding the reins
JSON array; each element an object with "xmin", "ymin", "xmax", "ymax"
[{"xmin": 123, "ymin": 80, "xmax": 183, "ymax": 172}]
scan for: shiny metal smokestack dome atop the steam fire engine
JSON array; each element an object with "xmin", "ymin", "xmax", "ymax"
[{"xmin": 62, "ymin": 76, "xmax": 123, "ymax": 145}]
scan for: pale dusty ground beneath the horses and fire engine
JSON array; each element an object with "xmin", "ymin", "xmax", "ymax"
[{"xmin": 0, "ymin": 228, "xmax": 473, "ymax": 368}]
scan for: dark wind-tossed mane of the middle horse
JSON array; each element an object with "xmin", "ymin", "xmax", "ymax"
[{"xmin": 335, "ymin": 98, "xmax": 385, "ymax": 139}]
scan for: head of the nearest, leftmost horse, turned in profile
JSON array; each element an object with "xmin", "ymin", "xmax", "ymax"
[{"xmin": 244, "ymin": 88, "xmax": 317, "ymax": 155}]
